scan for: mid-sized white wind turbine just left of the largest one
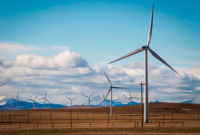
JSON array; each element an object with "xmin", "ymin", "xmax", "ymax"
[{"xmin": 102, "ymin": 72, "xmax": 127, "ymax": 117}]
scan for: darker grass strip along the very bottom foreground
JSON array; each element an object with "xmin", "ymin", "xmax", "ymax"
[{"xmin": 0, "ymin": 127, "xmax": 200, "ymax": 135}]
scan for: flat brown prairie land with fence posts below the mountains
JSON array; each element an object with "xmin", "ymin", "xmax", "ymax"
[{"xmin": 0, "ymin": 103, "xmax": 200, "ymax": 135}]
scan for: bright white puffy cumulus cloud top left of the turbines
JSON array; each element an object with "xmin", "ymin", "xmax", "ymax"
[{"xmin": 13, "ymin": 50, "xmax": 88, "ymax": 68}]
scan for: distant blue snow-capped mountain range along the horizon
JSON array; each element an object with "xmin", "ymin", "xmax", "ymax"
[{"xmin": 0, "ymin": 95, "xmax": 194, "ymax": 110}]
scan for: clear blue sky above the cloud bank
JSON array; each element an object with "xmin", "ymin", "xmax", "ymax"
[{"xmin": 0, "ymin": 0, "xmax": 200, "ymax": 66}]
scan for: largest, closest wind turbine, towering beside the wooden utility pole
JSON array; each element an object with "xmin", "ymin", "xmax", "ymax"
[{"xmin": 109, "ymin": 5, "xmax": 180, "ymax": 123}]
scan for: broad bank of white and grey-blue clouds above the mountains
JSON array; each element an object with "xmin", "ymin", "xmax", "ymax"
[{"xmin": 0, "ymin": 50, "xmax": 200, "ymax": 104}]
